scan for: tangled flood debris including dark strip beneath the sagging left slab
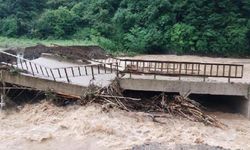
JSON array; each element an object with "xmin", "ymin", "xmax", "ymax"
[{"xmin": 0, "ymin": 79, "xmax": 226, "ymax": 128}]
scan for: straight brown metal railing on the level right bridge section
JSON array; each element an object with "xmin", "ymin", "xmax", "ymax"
[{"xmin": 120, "ymin": 59, "xmax": 244, "ymax": 82}]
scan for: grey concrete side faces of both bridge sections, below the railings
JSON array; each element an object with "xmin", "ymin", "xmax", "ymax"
[{"xmin": 0, "ymin": 67, "xmax": 250, "ymax": 118}]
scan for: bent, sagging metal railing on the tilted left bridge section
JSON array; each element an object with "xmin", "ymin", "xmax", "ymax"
[{"xmin": 0, "ymin": 51, "xmax": 118, "ymax": 83}]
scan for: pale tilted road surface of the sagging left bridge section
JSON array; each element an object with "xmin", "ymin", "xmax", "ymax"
[{"xmin": 32, "ymin": 56, "xmax": 116, "ymax": 87}]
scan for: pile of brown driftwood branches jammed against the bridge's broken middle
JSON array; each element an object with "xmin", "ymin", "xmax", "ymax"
[{"xmin": 81, "ymin": 80, "xmax": 225, "ymax": 128}]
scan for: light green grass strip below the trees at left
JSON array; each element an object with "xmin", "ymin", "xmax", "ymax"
[{"xmin": 0, "ymin": 36, "xmax": 98, "ymax": 48}]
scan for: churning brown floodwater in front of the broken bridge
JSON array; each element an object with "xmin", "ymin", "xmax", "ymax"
[{"xmin": 0, "ymin": 101, "xmax": 250, "ymax": 150}]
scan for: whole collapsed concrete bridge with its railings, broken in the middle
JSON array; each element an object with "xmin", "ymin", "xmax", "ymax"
[{"xmin": 1, "ymin": 49, "xmax": 250, "ymax": 117}]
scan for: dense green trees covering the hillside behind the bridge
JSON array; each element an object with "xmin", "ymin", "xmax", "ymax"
[{"xmin": 0, "ymin": 0, "xmax": 250, "ymax": 56}]
